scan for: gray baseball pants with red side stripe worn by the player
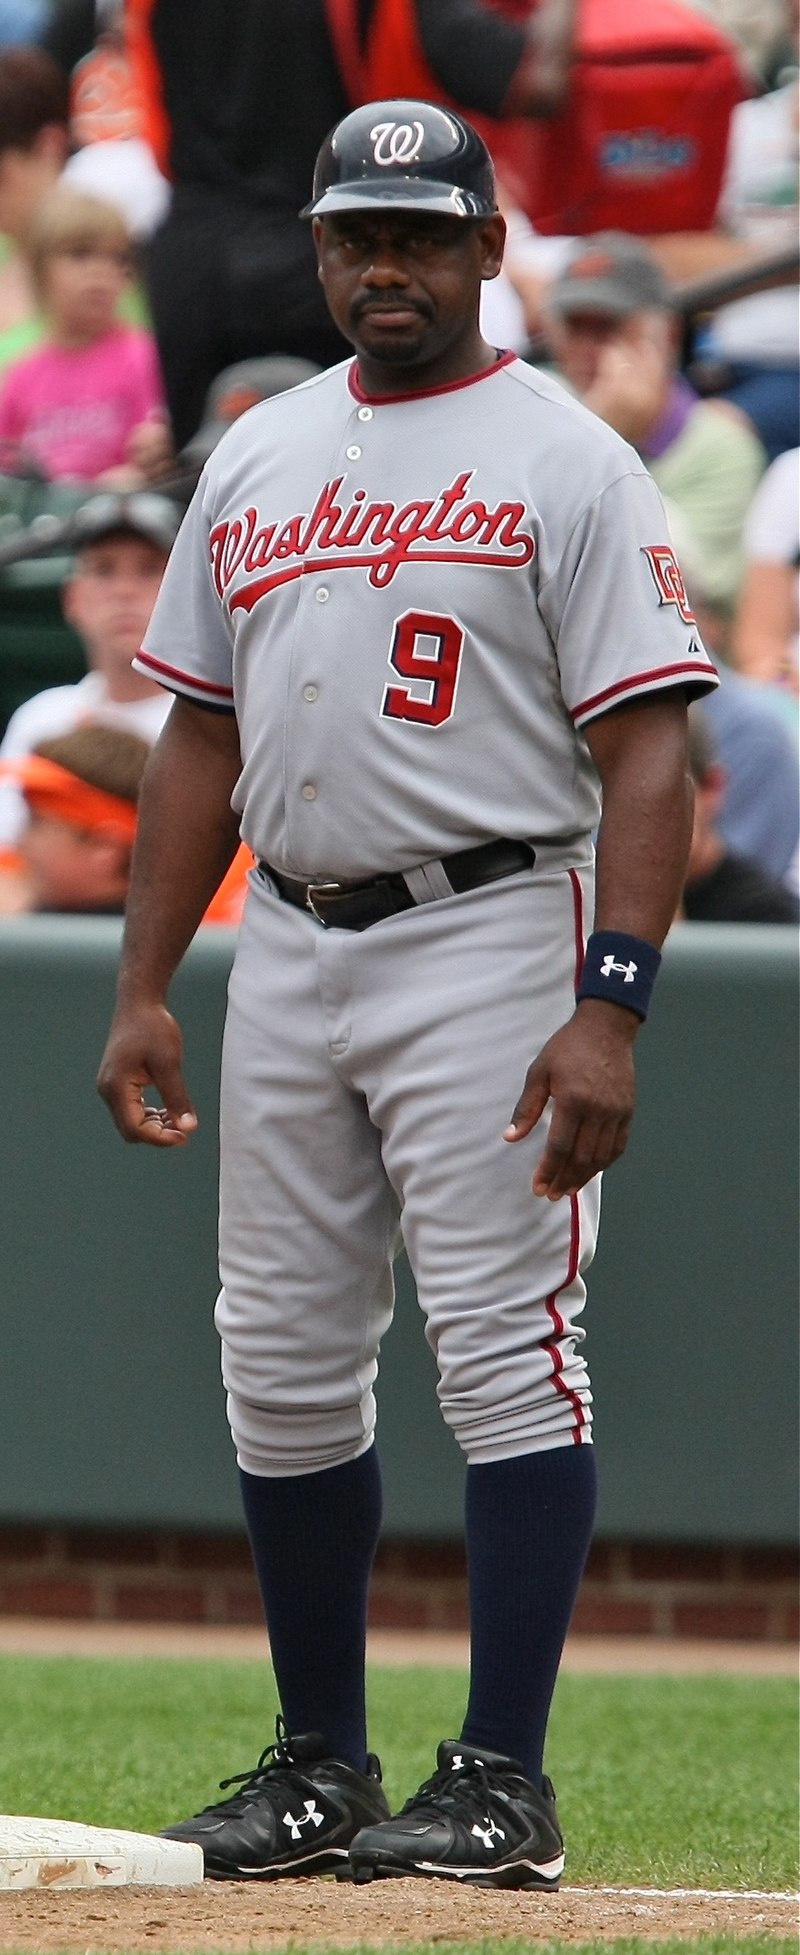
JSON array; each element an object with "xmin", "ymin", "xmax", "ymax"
[{"xmin": 215, "ymin": 862, "xmax": 600, "ymax": 1476}]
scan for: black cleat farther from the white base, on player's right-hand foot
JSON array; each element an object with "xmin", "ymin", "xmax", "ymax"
[{"xmin": 350, "ymin": 1742, "xmax": 563, "ymax": 1892}]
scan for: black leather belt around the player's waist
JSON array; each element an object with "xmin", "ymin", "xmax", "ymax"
[{"xmin": 258, "ymin": 837, "xmax": 536, "ymax": 931}]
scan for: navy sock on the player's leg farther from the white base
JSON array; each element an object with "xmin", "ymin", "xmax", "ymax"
[{"xmin": 462, "ymin": 1445, "xmax": 597, "ymax": 1787}]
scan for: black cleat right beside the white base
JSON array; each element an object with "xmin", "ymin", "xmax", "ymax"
[{"xmin": 160, "ymin": 1718, "xmax": 389, "ymax": 1881}]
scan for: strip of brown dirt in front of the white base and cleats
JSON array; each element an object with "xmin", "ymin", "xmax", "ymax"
[{"xmin": 0, "ymin": 1881, "xmax": 798, "ymax": 1955}]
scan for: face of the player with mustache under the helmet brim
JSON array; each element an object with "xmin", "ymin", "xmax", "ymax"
[{"xmin": 313, "ymin": 209, "xmax": 505, "ymax": 368}]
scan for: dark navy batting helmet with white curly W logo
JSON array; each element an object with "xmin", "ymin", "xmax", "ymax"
[{"xmin": 301, "ymin": 100, "xmax": 497, "ymax": 217}]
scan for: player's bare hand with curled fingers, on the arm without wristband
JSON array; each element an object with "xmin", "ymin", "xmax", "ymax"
[{"xmin": 98, "ymin": 1005, "xmax": 198, "ymax": 1148}]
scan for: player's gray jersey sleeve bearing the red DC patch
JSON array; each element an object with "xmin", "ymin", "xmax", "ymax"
[{"xmin": 540, "ymin": 471, "xmax": 718, "ymax": 727}]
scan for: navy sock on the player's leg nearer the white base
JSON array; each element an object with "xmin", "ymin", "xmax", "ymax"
[{"xmin": 239, "ymin": 1447, "xmax": 381, "ymax": 1771}]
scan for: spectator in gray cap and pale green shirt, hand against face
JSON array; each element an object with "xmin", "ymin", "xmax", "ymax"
[{"xmin": 544, "ymin": 231, "xmax": 765, "ymax": 604}]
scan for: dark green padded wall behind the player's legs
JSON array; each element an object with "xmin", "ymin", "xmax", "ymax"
[{"xmin": 0, "ymin": 919, "xmax": 798, "ymax": 1542}]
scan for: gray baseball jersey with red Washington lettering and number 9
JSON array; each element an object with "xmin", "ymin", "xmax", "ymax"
[{"xmin": 139, "ymin": 354, "xmax": 714, "ymax": 878}]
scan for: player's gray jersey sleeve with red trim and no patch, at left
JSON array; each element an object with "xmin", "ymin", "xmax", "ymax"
[{"xmin": 133, "ymin": 465, "xmax": 233, "ymax": 712}]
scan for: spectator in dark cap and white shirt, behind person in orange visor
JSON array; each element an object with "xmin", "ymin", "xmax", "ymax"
[{"xmin": 0, "ymin": 491, "xmax": 180, "ymax": 858}]
